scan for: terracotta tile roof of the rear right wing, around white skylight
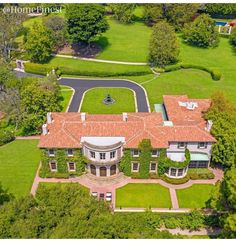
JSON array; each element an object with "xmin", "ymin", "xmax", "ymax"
[{"xmin": 163, "ymin": 95, "xmax": 211, "ymax": 128}]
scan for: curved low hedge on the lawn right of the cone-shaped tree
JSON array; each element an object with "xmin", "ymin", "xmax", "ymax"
[{"xmin": 159, "ymin": 63, "xmax": 222, "ymax": 81}]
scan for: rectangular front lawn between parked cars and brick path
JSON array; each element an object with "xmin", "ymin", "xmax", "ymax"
[{"xmin": 116, "ymin": 183, "xmax": 171, "ymax": 208}]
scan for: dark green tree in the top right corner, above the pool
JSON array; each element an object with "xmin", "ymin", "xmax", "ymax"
[{"xmin": 205, "ymin": 3, "xmax": 236, "ymax": 15}]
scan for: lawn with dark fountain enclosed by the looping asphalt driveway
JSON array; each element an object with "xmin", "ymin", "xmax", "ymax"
[{"xmin": 81, "ymin": 88, "xmax": 135, "ymax": 114}]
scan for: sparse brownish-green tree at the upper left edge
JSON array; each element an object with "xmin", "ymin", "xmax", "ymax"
[{"xmin": 0, "ymin": 5, "xmax": 26, "ymax": 62}]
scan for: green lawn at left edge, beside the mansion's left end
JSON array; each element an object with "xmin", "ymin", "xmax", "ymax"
[{"xmin": 0, "ymin": 140, "xmax": 40, "ymax": 197}]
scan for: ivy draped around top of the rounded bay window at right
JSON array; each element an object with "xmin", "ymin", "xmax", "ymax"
[{"xmin": 158, "ymin": 149, "xmax": 190, "ymax": 175}]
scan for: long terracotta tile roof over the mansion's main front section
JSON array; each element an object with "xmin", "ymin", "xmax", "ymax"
[{"xmin": 39, "ymin": 101, "xmax": 215, "ymax": 148}]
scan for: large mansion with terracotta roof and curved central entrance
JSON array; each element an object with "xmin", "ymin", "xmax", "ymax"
[{"xmin": 39, "ymin": 95, "xmax": 215, "ymax": 178}]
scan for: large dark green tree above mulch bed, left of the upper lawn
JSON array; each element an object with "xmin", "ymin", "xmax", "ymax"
[{"xmin": 65, "ymin": 4, "xmax": 109, "ymax": 45}]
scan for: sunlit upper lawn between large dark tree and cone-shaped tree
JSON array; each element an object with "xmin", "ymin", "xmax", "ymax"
[{"xmin": 97, "ymin": 18, "xmax": 152, "ymax": 62}]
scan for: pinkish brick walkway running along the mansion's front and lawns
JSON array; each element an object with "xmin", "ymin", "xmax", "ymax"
[{"xmin": 31, "ymin": 167, "xmax": 224, "ymax": 212}]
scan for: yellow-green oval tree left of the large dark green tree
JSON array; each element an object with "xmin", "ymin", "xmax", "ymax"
[{"xmin": 25, "ymin": 22, "xmax": 54, "ymax": 63}]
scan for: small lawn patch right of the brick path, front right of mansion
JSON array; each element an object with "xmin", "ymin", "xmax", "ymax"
[{"xmin": 176, "ymin": 184, "xmax": 214, "ymax": 208}]
